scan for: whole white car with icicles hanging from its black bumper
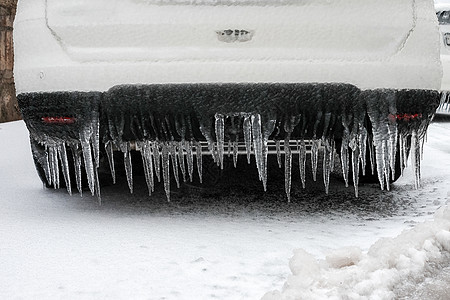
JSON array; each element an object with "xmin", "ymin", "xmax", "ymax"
[{"xmin": 14, "ymin": 0, "xmax": 442, "ymax": 199}]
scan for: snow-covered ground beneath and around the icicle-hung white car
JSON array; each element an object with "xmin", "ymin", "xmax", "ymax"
[{"xmin": 0, "ymin": 122, "xmax": 450, "ymax": 299}]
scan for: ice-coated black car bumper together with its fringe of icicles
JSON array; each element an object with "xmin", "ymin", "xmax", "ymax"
[{"xmin": 19, "ymin": 84, "xmax": 440, "ymax": 201}]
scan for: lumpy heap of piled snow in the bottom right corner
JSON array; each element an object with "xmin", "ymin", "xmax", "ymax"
[{"xmin": 263, "ymin": 207, "xmax": 450, "ymax": 300}]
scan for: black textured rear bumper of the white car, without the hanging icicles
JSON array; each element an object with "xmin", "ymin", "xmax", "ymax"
[{"xmin": 18, "ymin": 83, "xmax": 440, "ymax": 144}]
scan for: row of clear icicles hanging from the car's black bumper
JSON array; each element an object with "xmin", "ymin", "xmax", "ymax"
[{"xmin": 22, "ymin": 85, "xmax": 438, "ymax": 201}]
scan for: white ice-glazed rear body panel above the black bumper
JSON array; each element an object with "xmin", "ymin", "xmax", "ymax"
[{"xmin": 14, "ymin": 0, "xmax": 442, "ymax": 93}]
